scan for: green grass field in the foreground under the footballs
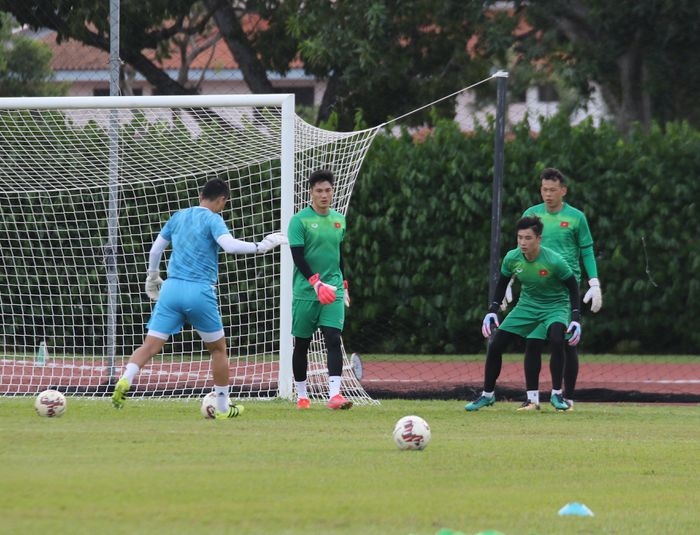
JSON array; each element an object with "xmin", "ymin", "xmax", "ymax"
[{"xmin": 0, "ymin": 397, "xmax": 700, "ymax": 535}]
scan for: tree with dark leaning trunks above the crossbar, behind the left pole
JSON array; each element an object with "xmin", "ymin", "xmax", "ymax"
[{"xmin": 0, "ymin": 0, "xmax": 295, "ymax": 95}]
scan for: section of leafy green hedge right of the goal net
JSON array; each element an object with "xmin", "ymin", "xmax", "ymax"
[{"xmin": 345, "ymin": 118, "xmax": 700, "ymax": 353}]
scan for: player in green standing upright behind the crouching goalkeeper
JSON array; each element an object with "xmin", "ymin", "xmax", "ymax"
[{"xmin": 504, "ymin": 168, "xmax": 603, "ymax": 407}]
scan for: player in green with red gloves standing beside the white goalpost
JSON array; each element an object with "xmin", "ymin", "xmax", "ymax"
[{"xmin": 288, "ymin": 170, "xmax": 352, "ymax": 409}]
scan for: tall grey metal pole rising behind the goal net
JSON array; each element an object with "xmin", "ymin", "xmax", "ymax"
[{"xmin": 105, "ymin": 0, "xmax": 121, "ymax": 381}]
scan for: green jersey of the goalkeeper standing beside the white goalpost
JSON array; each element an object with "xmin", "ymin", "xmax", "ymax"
[{"xmin": 287, "ymin": 206, "xmax": 345, "ymax": 301}]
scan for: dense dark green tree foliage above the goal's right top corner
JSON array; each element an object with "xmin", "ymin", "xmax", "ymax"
[{"xmin": 287, "ymin": 0, "xmax": 489, "ymax": 128}]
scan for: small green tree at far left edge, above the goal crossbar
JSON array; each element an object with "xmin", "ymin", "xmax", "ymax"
[{"xmin": 0, "ymin": 13, "xmax": 66, "ymax": 97}]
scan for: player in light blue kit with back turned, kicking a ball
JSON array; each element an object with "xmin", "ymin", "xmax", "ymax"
[{"xmin": 112, "ymin": 179, "xmax": 287, "ymax": 418}]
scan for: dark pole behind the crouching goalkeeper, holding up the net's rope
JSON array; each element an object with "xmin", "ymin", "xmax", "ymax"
[{"xmin": 487, "ymin": 71, "xmax": 508, "ymax": 305}]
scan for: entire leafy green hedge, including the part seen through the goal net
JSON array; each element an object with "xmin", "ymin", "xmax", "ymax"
[{"xmin": 0, "ymin": 112, "xmax": 700, "ymax": 353}]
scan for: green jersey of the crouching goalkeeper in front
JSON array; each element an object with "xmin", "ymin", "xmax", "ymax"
[{"xmin": 501, "ymin": 247, "xmax": 573, "ymax": 312}]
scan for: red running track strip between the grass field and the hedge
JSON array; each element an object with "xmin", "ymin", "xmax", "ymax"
[{"xmin": 0, "ymin": 359, "xmax": 700, "ymax": 397}]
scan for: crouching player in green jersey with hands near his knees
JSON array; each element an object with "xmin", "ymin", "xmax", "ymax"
[{"xmin": 464, "ymin": 217, "xmax": 581, "ymax": 411}]
